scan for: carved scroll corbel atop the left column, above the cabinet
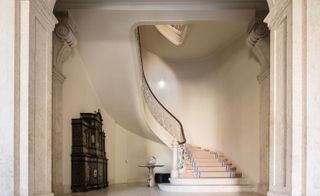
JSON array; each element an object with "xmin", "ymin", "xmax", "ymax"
[{"xmin": 53, "ymin": 12, "xmax": 77, "ymax": 79}]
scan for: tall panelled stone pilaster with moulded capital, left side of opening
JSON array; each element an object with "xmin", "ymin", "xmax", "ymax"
[{"xmin": 17, "ymin": 0, "xmax": 57, "ymax": 196}]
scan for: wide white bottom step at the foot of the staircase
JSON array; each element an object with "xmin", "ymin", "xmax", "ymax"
[{"xmin": 158, "ymin": 183, "xmax": 255, "ymax": 193}]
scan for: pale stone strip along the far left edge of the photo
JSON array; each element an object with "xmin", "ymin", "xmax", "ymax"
[{"xmin": 0, "ymin": 0, "xmax": 21, "ymax": 196}]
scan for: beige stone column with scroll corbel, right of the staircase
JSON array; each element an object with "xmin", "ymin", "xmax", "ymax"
[{"xmin": 247, "ymin": 13, "xmax": 270, "ymax": 194}]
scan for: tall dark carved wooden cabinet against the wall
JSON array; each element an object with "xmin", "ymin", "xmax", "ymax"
[{"xmin": 71, "ymin": 110, "xmax": 108, "ymax": 192}]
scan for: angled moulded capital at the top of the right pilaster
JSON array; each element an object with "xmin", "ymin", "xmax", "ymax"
[{"xmin": 264, "ymin": 0, "xmax": 292, "ymax": 29}]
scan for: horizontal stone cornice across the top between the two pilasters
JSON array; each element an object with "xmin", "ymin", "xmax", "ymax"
[{"xmin": 55, "ymin": 0, "xmax": 268, "ymax": 10}]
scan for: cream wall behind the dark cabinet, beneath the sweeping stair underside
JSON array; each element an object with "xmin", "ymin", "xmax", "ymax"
[{"xmin": 63, "ymin": 48, "xmax": 171, "ymax": 192}]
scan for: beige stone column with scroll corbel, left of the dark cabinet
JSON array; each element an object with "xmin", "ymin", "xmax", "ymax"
[{"xmin": 52, "ymin": 12, "xmax": 77, "ymax": 195}]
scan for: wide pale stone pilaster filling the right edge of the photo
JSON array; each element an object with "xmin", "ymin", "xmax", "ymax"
[{"xmin": 265, "ymin": 0, "xmax": 320, "ymax": 196}]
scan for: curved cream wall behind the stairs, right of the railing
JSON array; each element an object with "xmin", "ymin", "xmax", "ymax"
[{"xmin": 143, "ymin": 37, "xmax": 259, "ymax": 182}]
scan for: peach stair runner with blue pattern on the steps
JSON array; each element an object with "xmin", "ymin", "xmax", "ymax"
[{"xmin": 179, "ymin": 144, "xmax": 242, "ymax": 178}]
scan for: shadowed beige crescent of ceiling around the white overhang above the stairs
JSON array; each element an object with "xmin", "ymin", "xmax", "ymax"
[{"xmin": 140, "ymin": 21, "xmax": 248, "ymax": 60}]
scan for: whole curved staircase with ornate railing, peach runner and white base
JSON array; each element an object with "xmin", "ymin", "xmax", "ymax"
[{"xmin": 136, "ymin": 29, "xmax": 254, "ymax": 192}]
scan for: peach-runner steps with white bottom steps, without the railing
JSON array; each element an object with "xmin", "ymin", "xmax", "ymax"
[{"xmin": 158, "ymin": 145, "xmax": 254, "ymax": 192}]
